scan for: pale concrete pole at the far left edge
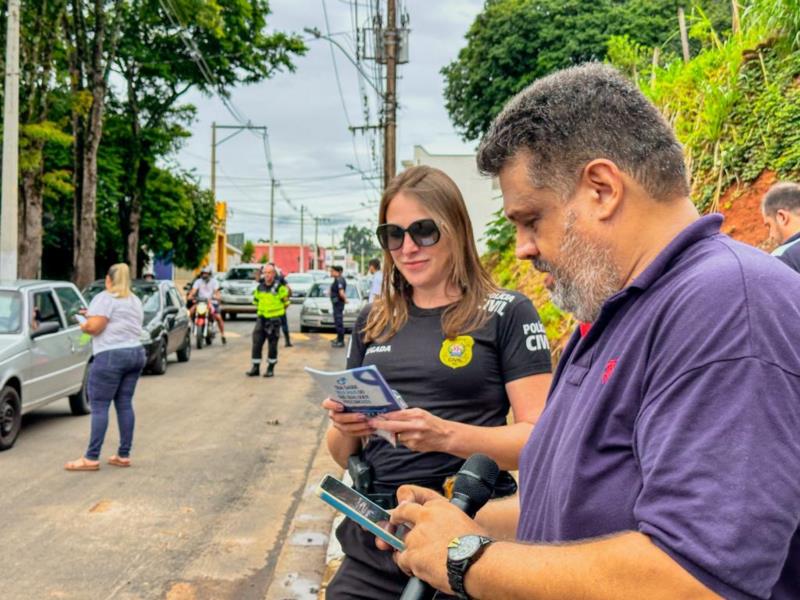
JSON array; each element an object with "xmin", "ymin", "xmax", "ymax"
[{"xmin": 0, "ymin": 0, "xmax": 19, "ymax": 280}]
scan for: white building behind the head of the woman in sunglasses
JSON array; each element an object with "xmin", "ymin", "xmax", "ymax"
[{"xmin": 403, "ymin": 146, "xmax": 503, "ymax": 254}]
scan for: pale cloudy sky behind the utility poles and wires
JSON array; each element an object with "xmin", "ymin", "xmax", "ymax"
[{"xmin": 172, "ymin": 0, "xmax": 483, "ymax": 245}]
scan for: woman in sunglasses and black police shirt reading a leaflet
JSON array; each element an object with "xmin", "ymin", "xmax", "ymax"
[{"xmin": 322, "ymin": 166, "xmax": 551, "ymax": 600}]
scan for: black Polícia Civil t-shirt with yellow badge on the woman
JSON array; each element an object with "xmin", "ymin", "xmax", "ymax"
[{"xmin": 347, "ymin": 290, "xmax": 551, "ymax": 485}]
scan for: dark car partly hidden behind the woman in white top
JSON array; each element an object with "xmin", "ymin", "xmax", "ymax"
[{"xmin": 84, "ymin": 279, "xmax": 192, "ymax": 375}]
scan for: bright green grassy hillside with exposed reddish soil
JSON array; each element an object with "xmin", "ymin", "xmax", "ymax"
[{"xmin": 486, "ymin": 0, "xmax": 800, "ymax": 358}]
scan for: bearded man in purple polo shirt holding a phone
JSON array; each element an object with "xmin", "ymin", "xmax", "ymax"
[{"xmin": 382, "ymin": 64, "xmax": 800, "ymax": 600}]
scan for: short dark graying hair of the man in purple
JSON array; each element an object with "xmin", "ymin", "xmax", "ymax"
[{"xmin": 478, "ymin": 63, "xmax": 689, "ymax": 201}]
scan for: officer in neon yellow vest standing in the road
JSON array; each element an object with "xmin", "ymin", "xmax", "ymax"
[{"xmin": 247, "ymin": 265, "xmax": 289, "ymax": 377}]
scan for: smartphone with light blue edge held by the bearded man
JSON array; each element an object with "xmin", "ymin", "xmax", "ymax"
[{"xmin": 317, "ymin": 475, "xmax": 406, "ymax": 552}]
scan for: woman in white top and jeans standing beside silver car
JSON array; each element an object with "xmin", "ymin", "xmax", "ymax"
[{"xmin": 64, "ymin": 263, "xmax": 145, "ymax": 471}]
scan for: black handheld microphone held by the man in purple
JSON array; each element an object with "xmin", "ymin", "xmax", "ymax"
[{"xmin": 400, "ymin": 454, "xmax": 500, "ymax": 600}]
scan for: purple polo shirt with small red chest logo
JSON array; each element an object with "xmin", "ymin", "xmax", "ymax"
[{"xmin": 517, "ymin": 215, "xmax": 800, "ymax": 599}]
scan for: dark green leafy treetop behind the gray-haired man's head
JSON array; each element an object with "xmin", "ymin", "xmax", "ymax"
[{"xmin": 442, "ymin": 0, "xmax": 730, "ymax": 140}]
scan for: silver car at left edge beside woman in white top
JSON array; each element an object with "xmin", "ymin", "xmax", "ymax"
[{"xmin": 0, "ymin": 280, "xmax": 91, "ymax": 450}]
